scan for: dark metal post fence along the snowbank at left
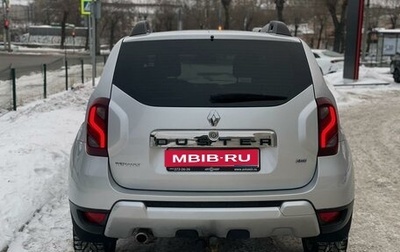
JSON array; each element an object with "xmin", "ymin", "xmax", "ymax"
[{"xmin": 0, "ymin": 57, "xmax": 106, "ymax": 114}]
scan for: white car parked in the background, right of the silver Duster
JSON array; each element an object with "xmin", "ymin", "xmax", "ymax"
[{"xmin": 312, "ymin": 49, "xmax": 344, "ymax": 75}]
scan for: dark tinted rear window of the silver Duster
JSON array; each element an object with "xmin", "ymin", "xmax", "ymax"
[{"xmin": 113, "ymin": 39, "xmax": 312, "ymax": 107}]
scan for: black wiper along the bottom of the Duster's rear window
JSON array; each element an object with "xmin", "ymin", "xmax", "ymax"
[{"xmin": 210, "ymin": 93, "xmax": 287, "ymax": 103}]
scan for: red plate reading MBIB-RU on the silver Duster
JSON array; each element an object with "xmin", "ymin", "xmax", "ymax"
[{"xmin": 164, "ymin": 149, "xmax": 260, "ymax": 172}]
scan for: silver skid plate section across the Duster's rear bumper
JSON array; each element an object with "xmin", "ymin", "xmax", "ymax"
[{"xmin": 105, "ymin": 201, "xmax": 319, "ymax": 238}]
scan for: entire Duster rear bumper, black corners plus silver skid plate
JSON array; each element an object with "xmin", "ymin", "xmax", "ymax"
[{"xmin": 70, "ymin": 201, "xmax": 353, "ymax": 241}]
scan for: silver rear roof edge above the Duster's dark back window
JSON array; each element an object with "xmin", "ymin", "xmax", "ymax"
[{"xmin": 124, "ymin": 30, "xmax": 300, "ymax": 43}]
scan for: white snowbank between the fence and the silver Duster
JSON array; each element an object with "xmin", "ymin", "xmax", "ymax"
[{"xmin": 0, "ymin": 84, "xmax": 92, "ymax": 251}]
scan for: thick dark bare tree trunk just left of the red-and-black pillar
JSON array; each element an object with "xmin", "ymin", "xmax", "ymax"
[{"xmin": 325, "ymin": 0, "xmax": 348, "ymax": 52}]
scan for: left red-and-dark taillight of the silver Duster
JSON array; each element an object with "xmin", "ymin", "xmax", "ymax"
[{"xmin": 86, "ymin": 98, "xmax": 110, "ymax": 157}]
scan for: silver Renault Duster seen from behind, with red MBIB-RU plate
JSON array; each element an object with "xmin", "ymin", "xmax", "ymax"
[{"xmin": 69, "ymin": 21, "xmax": 354, "ymax": 251}]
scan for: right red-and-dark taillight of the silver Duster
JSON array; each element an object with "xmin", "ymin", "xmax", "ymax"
[{"xmin": 317, "ymin": 98, "xmax": 339, "ymax": 156}]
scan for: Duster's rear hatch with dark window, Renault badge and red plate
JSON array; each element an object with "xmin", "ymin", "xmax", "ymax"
[{"xmin": 108, "ymin": 35, "xmax": 318, "ymax": 191}]
